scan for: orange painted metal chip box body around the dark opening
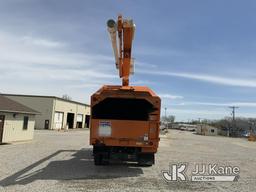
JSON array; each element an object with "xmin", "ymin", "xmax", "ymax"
[{"xmin": 90, "ymin": 85, "xmax": 161, "ymax": 152}]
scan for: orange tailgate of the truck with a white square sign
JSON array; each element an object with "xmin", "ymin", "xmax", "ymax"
[{"xmin": 91, "ymin": 119, "xmax": 158, "ymax": 147}]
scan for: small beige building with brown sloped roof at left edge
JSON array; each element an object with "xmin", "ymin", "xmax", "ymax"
[{"xmin": 0, "ymin": 95, "xmax": 38, "ymax": 143}]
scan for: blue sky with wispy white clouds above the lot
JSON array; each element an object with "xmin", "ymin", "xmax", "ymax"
[{"xmin": 0, "ymin": 0, "xmax": 256, "ymax": 120}]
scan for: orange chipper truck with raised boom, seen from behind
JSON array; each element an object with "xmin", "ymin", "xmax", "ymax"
[{"xmin": 90, "ymin": 15, "xmax": 161, "ymax": 166}]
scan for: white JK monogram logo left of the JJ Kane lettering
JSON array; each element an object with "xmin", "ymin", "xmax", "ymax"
[{"xmin": 162, "ymin": 163, "xmax": 187, "ymax": 182}]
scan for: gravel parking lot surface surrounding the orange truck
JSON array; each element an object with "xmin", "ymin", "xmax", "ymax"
[{"xmin": 0, "ymin": 130, "xmax": 256, "ymax": 192}]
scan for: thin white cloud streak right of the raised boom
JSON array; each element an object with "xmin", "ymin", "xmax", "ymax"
[{"xmin": 137, "ymin": 70, "xmax": 256, "ymax": 88}]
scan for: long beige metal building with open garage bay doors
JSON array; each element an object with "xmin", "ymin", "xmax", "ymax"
[{"xmin": 2, "ymin": 94, "xmax": 90, "ymax": 129}]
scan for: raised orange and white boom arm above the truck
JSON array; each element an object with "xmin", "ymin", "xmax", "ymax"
[{"xmin": 107, "ymin": 15, "xmax": 135, "ymax": 86}]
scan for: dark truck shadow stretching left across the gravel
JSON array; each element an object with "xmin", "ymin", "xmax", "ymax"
[{"xmin": 0, "ymin": 149, "xmax": 143, "ymax": 187}]
